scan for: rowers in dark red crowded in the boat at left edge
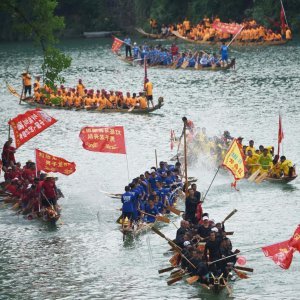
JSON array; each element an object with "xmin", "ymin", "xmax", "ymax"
[{"xmin": 0, "ymin": 138, "xmax": 63, "ymax": 220}]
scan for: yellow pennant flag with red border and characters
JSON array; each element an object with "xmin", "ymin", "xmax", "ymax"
[{"xmin": 222, "ymin": 139, "xmax": 245, "ymax": 187}]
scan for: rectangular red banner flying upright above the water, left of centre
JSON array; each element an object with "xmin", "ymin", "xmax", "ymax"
[{"xmin": 79, "ymin": 126, "xmax": 126, "ymax": 154}]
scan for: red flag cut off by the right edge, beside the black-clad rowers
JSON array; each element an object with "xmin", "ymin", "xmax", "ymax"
[{"xmin": 261, "ymin": 225, "xmax": 300, "ymax": 269}]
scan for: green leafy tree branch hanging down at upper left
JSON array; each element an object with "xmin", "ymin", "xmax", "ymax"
[{"xmin": 0, "ymin": 0, "xmax": 71, "ymax": 85}]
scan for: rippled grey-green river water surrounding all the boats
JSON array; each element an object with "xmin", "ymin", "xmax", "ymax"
[{"xmin": 0, "ymin": 40, "xmax": 300, "ymax": 299}]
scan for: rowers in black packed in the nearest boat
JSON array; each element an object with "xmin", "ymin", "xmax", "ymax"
[{"xmin": 174, "ymin": 185, "xmax": 239, "ymax": 285}]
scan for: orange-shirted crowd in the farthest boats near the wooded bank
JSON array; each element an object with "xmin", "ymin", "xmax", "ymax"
[{"xmin": 150, "ymin": 17, "xmax": 292, "ymax": 42}]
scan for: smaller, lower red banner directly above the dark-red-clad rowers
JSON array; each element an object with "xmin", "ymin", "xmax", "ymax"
[{"xmin": 35, "ymin": 149, "xmax": 76, "ymax": 175}]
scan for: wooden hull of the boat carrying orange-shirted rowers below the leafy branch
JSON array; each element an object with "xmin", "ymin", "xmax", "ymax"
[{"xmin": 7, "ymin": 84, "xmax": 164, "ymax": 114}]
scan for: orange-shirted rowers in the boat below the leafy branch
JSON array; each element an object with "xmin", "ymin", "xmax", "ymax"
[{"xmin": 22, "ymin": 73, "xmax": 154, "ymax": 110}]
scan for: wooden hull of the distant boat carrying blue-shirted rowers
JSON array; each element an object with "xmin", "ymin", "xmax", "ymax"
[{"xmin": 117, "ymin": 55, "xmax": 235, "ymax": 71}]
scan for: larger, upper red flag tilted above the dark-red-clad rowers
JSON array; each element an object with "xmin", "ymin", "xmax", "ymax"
[{"xmin": 8, "ymin": 108, "xmax": 57, "ymax": 148}]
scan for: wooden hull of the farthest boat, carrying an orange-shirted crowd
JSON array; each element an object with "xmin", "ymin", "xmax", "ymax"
[{"xmin": 172, "ymin": 31, "xmax": 287, "ymax": 47}]
